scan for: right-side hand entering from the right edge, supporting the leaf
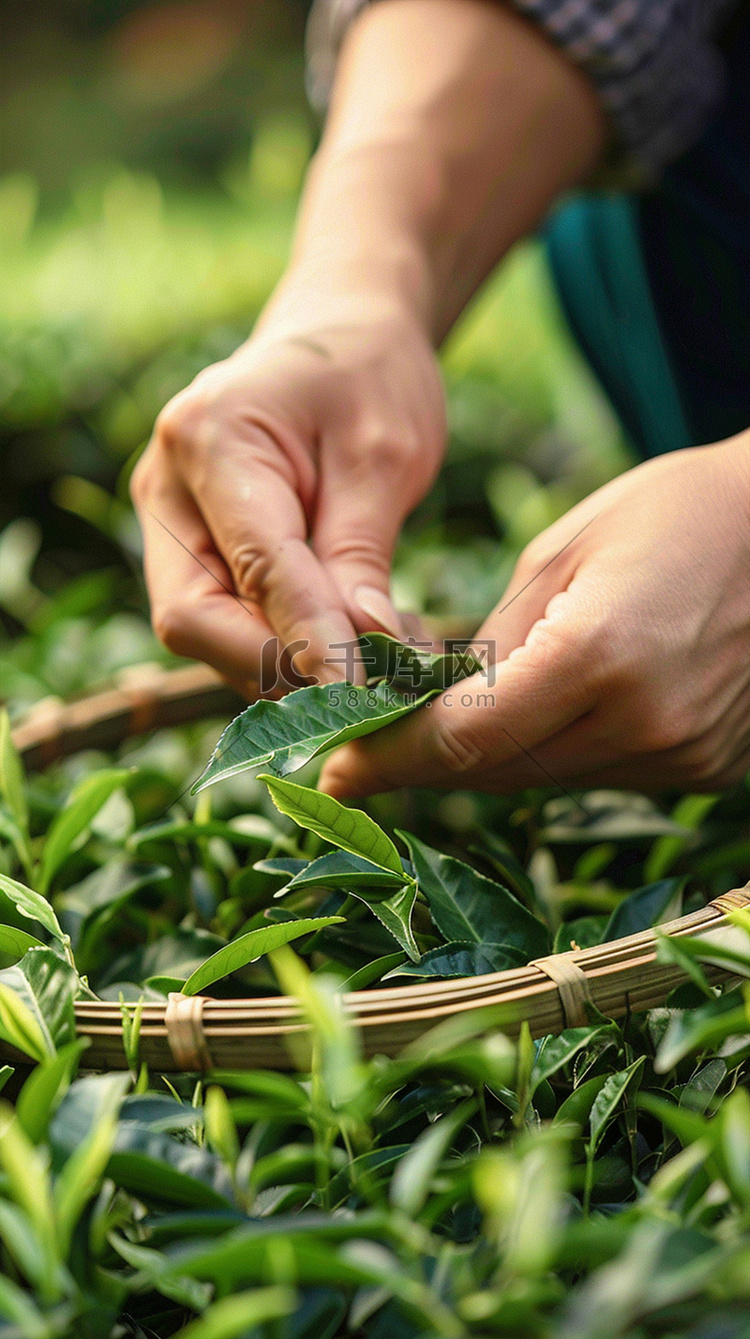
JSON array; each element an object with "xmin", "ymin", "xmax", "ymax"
[{"xmin": 321, "ymin": 432, "xmax": 750, "ymax": 797}]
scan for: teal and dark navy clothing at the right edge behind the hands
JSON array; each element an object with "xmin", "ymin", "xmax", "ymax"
[{"xmin": 545, "ymin": 19, "xmax": 750, "ymax": 457}]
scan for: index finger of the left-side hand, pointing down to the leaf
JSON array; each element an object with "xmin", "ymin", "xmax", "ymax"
[{"xmin": 166, "ymin": 426, "xmax": 356, "ymax": 683}]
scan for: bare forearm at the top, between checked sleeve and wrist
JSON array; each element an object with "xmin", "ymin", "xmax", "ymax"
[{"xmin": 261, "ymin": 0, "xmax": 604, "ymax": 341}]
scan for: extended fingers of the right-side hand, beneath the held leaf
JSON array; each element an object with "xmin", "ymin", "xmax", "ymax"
[{"xmin": 321, "ymin": 585, "xmax": 600, "ymax": 797}]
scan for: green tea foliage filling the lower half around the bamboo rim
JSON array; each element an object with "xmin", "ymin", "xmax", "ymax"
[{"xmin": 0, "ymin": 639, "xmax": 750, "ymax": 1339}]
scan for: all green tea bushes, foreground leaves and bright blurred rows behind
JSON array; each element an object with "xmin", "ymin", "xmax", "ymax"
[{"xmin": 0, "ymin": 115, "xmax": 750, "ymax": 1339}]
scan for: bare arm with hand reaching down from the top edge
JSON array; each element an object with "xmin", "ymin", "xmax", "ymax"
[{"xmin": 133, "ymin": 0, "xmax": 604, "ymax": 696}]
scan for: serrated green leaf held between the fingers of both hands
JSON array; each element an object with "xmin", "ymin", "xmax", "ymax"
[{"xmin": 192, "ymin": 683, "xmax": 433, "ymax": 794}]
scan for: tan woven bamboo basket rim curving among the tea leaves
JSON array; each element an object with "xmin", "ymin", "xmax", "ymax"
[{"xmin": 8, "ymin": 665, "xmax": 750, "ymax": 1073}]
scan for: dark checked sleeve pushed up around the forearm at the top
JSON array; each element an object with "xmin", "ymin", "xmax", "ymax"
[{"xmin": 307, "ymin": 0, "xmax": 737, "ymax": 179}]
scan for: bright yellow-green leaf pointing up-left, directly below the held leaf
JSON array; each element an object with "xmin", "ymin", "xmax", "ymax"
[{"xmin": 258, "ymin": 775, "xmax": 403, "ymax": 878}]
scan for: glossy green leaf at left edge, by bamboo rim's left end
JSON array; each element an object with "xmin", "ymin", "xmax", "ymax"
[{"xmin": 0, "ymin": 948, "xmax": 78, "ymax": 1060}]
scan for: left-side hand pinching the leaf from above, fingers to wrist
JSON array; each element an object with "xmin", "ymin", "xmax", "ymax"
[{"xmin": 131, "ymin": 291, "xmax": 445, "ymax": 699}]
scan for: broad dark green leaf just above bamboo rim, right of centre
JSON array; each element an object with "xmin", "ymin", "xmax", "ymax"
[{"xmin": 398, "ymin": 833, "xmax": 549, "ymax": 961}]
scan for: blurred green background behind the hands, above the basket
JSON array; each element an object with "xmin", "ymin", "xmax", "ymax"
[{"xmin": 0, "ymin": 0, "xmax": 629, "ymax": 711}]
